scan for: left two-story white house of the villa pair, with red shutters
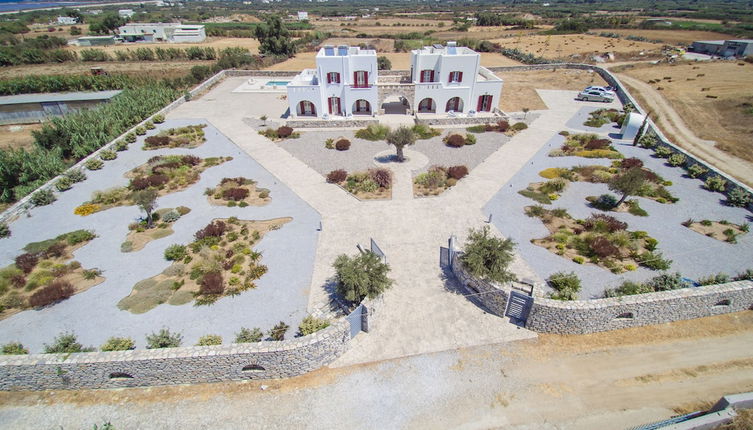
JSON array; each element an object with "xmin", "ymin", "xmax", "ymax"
[{"xmin": 287, "ymin": 45, "xmax": 378, "ymax": 118}]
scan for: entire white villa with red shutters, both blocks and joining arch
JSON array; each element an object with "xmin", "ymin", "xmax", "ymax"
[{"xmin": 287, "ymin": 42, "xmax": 502, "ymax": 118}]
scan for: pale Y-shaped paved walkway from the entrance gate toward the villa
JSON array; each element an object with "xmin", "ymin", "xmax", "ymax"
[{"xmin": 164, "ymin": 79, "xmax": 616, "ymax": 366}]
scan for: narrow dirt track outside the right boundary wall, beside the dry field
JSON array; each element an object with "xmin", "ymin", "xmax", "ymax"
[{"xmin": 616, "ymin": 73, "xmax": 753, "ymax": 186}]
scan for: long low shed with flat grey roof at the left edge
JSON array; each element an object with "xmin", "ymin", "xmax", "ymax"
[{"xmin": 0, "ymin": 90, "xmax": 121, "ymax": 124}]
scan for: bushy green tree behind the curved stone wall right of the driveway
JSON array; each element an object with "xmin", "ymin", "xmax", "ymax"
[{"xmin": 460, "ymin": 226, "xmax": 517, "ymax": 283}]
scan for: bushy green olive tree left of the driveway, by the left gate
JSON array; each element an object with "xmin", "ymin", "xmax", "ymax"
[{"xmin": 333, "ymin": 252, "xmax": 392, "ymax": 303}]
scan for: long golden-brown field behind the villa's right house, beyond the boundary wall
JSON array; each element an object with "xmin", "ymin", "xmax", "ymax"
[{"xmin": 492, "ymin": 34, "xmax": 662, "ymax": 59}]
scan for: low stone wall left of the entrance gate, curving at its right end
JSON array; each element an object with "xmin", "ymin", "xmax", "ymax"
[{"xmin": 0, "ymin": 319, "xmax": 350, "ymax": 391}]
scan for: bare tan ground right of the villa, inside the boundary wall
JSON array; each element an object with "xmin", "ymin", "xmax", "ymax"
[{"xmin": 497, "ymin": 69, "xmax": 607, "ymax": 112}]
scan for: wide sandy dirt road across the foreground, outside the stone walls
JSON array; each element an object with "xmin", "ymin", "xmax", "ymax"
[{"xmin": 0, "ymin": 311, "xmax": 753, "ymax": 430}]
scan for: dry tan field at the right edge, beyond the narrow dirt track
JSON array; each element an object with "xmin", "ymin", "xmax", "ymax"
[{"xmin": 622, "ymin": 61, "xmax": 753, "ymax": 165}]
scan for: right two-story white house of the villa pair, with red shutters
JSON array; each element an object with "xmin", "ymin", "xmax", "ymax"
[{"xmin": 411, "ymin": 42, "xmax": 502, "ymax": 113}]
